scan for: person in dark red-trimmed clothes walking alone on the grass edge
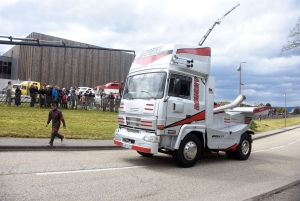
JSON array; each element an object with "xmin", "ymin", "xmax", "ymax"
[{"xmin": 46, "ymin": 103, "xmax": 66, "ymax": 147}]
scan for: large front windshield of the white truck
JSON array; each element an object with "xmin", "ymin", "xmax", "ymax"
[{"xmin": 123, "ymin": 72, "xmax": 167, "ymax": 99}]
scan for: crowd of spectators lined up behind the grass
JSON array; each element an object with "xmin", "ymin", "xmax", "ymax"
[{"xmin": 5, "ymin": 82, "xmax": 120, "ymax": 111}]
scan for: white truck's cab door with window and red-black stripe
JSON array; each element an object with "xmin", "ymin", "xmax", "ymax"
[{"xmin": 165, "ymin": 73, "xmax": 193, "ymax": 134}]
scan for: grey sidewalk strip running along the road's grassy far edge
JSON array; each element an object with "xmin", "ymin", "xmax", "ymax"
[{"xmin": 0, "ymin": 125, "xmax": 300, "ymax": 151}]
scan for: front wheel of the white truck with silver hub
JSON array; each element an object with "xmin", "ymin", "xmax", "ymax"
[{"xmin": 173, "ymin": 134, "xmax": 201, "ymax": 168}]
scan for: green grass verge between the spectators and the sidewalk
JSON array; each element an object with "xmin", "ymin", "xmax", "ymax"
[{"xmin": 0, "ymin": 106, "xmax": 300, "ymax": 140}]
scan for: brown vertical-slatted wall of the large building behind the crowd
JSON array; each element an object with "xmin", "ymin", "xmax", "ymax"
[{"xmin": 13, "ymin": 33, "xmax": 134, "ymax": 88}]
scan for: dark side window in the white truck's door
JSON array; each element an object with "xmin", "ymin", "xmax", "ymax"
[{"xmin": 168, "ymin": 74, "xmax": 192, "ymax": 99}]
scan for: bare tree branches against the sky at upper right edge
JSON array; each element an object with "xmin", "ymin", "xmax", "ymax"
[{"xmin": 281, "ymin": 17, "xmax": 300, "ymax": 55}]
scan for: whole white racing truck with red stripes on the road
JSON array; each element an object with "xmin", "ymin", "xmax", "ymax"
[{"xmin": 114, "ymin": 44, "xmax": 268, "ymax": 167}]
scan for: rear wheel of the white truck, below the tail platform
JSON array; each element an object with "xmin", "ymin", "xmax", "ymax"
[{"xmin": 235, "ymin": 135, "xmax": 252, "ymax": 161}]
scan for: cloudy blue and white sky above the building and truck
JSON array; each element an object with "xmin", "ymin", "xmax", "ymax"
[{"xmin": 0, "ymin": 0, "xmax": 300, "ymax": 107}]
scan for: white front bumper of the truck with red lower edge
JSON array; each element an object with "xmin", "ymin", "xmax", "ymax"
[{"xmin": 114, "ymin": 128, "xmax": 160, "ymax": 154}]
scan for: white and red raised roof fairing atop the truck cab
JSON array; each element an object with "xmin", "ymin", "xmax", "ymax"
[{"xmin": 130, "ymin": 44, "xmax": 211, "ymax": 76}]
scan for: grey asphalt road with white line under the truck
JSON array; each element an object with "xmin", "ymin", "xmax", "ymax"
[{"xmin": 0, "ymin": 128, "xmax": 300, "ymax": 201}]
